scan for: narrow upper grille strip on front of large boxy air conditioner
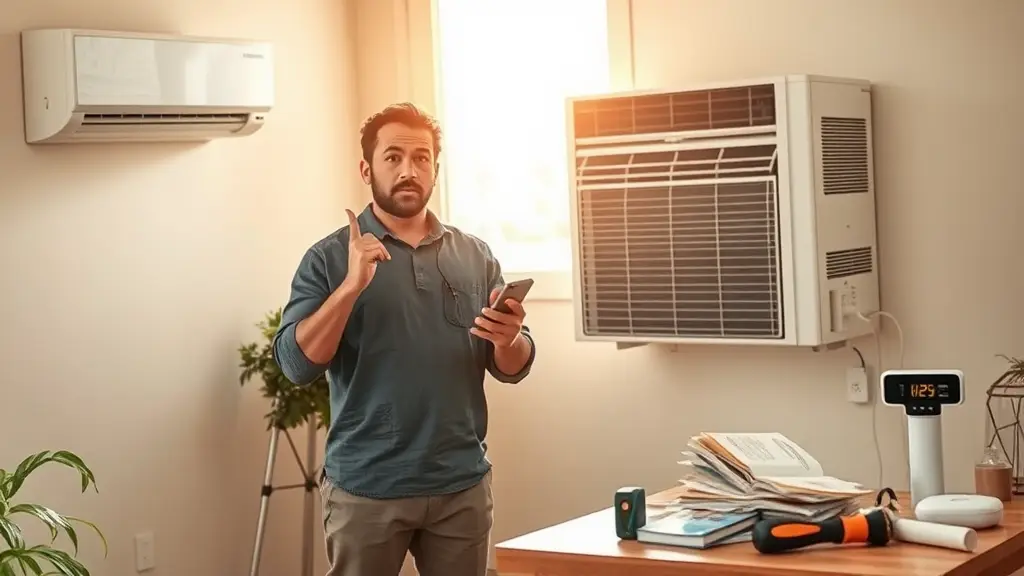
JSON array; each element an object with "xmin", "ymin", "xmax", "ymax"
[{"xmin": 572, "ymin": 84, "xmax": 775, "ymax": 138}]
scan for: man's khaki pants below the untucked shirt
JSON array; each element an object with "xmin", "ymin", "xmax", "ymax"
[{"xmin": 321, "ymin": 471, "xmax": 494, "ymax": 576}]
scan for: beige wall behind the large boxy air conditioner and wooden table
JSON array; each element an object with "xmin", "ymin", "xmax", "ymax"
[{"xmin": 366, "ymin": 0, "xmax": 1024, "ymax": 565}]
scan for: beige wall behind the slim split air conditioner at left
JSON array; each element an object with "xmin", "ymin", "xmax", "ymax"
[{"xmin": 0, "ymin": 0, "xmax": 357, "ymax": 576}]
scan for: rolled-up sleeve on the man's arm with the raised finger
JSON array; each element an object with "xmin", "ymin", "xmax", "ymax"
[{"xmin": 273, "ymin": 247, "xmax": 331, "ymax": 385}]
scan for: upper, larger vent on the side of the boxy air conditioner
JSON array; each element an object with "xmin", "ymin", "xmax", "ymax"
[{"xmin": 821, "ymin": 116, "xmax": 869, "ymax": 194}]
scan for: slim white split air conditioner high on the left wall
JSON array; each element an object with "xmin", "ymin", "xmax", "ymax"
[{"xmin": 22, "ymin": 29, "xmax": 274, "ymax": 143}]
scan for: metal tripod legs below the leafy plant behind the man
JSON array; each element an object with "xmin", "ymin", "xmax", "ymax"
[{"xmin": 249, "ymin": 416, "xmax": 319, "ymax": 576}]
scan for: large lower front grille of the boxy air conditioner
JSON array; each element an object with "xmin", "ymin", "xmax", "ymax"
[{"xmin": 579, "ymin": 172, "xmax": 783, "ymax": 338}]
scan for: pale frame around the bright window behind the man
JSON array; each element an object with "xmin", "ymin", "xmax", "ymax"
[{"xmin": 407, "ymin": 0, "xmax": 635, "ymax": 301}]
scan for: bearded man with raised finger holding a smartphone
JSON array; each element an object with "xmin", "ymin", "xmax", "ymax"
[{"xmin": 273, "ymin": 104, "xmax": 535, "ymax": 576}]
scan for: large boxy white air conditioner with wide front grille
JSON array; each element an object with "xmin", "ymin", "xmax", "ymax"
[{"xmin": 567, "ymin": 76, "xmax": 879, "ymax": 347}]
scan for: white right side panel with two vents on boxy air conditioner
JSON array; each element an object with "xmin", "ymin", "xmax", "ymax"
[{"xmin": 811, "ymin": 81, "xmax": 880, "ymax": 342}]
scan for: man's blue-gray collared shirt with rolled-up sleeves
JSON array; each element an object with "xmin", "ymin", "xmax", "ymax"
[{"xmin": 273, "ymin": 206, "xmax": 536, "ymax": 498}]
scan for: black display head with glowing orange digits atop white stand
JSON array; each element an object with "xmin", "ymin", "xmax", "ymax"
[{"xmin": 882, "ymin": 370, "xmax": 964, "ymax": 416}]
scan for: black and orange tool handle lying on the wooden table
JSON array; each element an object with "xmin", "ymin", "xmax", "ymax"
[{"xmin": 752, "ymin": 507, "xmax": 892, "ymax": 554}]
